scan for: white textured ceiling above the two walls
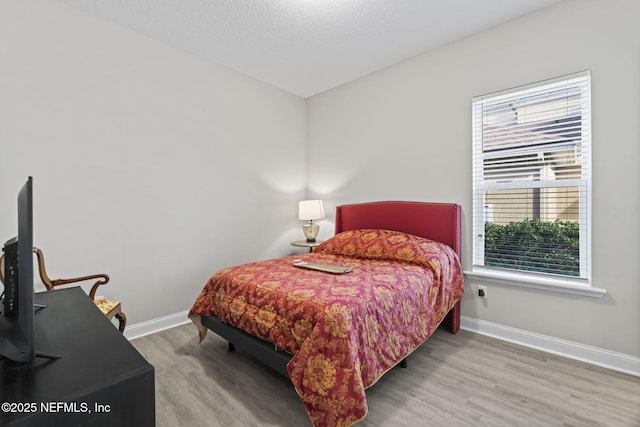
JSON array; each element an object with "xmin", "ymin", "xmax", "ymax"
[{"xmin": 62, "ymin": 0, "xmax": 559, "ymax": 97}]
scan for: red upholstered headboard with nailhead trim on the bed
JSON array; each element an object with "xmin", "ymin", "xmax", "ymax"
[{"xmin": 336, "ymin": 202, "xmax": 461, "ymax": 257}]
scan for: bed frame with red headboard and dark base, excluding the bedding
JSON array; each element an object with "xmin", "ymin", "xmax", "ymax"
[{"xmin": 202, "ymin": 201, "xmax": 461, "ymax": 377}]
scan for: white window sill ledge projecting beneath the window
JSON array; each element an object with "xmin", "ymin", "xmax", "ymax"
[{"xmin": 464, "ymin": 270, "xmax": 607, "ymax": 298}]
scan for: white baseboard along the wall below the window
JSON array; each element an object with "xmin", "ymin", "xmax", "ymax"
[{"xmin": 460, "ymin": 316, "xmax": 640, "ymax": 376}]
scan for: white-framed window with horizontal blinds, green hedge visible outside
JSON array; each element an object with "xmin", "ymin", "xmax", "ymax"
[{"xmin": 472, "ymin": 72, "xmax": 591, "ymax": 285}]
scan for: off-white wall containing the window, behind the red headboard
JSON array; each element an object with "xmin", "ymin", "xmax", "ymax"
[{"xmin": 307, "ymin": 0, "xmax": 640, "ymax": 356}]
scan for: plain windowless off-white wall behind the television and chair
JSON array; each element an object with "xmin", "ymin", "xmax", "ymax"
[{"xmin": 0, "ymin": 0, "xmax": 306, "ymax": 324}]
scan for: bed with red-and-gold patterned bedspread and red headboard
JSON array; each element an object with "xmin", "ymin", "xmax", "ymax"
[{"xmin": 189, "ymin": 201, "xmax": 464, "ymax": 426}]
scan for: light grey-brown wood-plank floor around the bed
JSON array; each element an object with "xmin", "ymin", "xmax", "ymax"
[{"xmin": 132, "ymin": 324, "xmax": 640, "ymax": 427}]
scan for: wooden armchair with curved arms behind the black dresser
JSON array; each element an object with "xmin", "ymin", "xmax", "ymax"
[{"xmin": 0, "ymin": 247, "xmax": 127, "ymax": 332}]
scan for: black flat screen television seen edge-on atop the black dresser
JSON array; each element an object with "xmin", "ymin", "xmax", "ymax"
[{"xmin": 0, "ymin": 177, "xmax": 56, "ymax": 363}]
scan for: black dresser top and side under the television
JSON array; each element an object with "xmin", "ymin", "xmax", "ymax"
[{"xmin": 0, "ymin": 287, "xmax": 155, "ymax": 427}]
